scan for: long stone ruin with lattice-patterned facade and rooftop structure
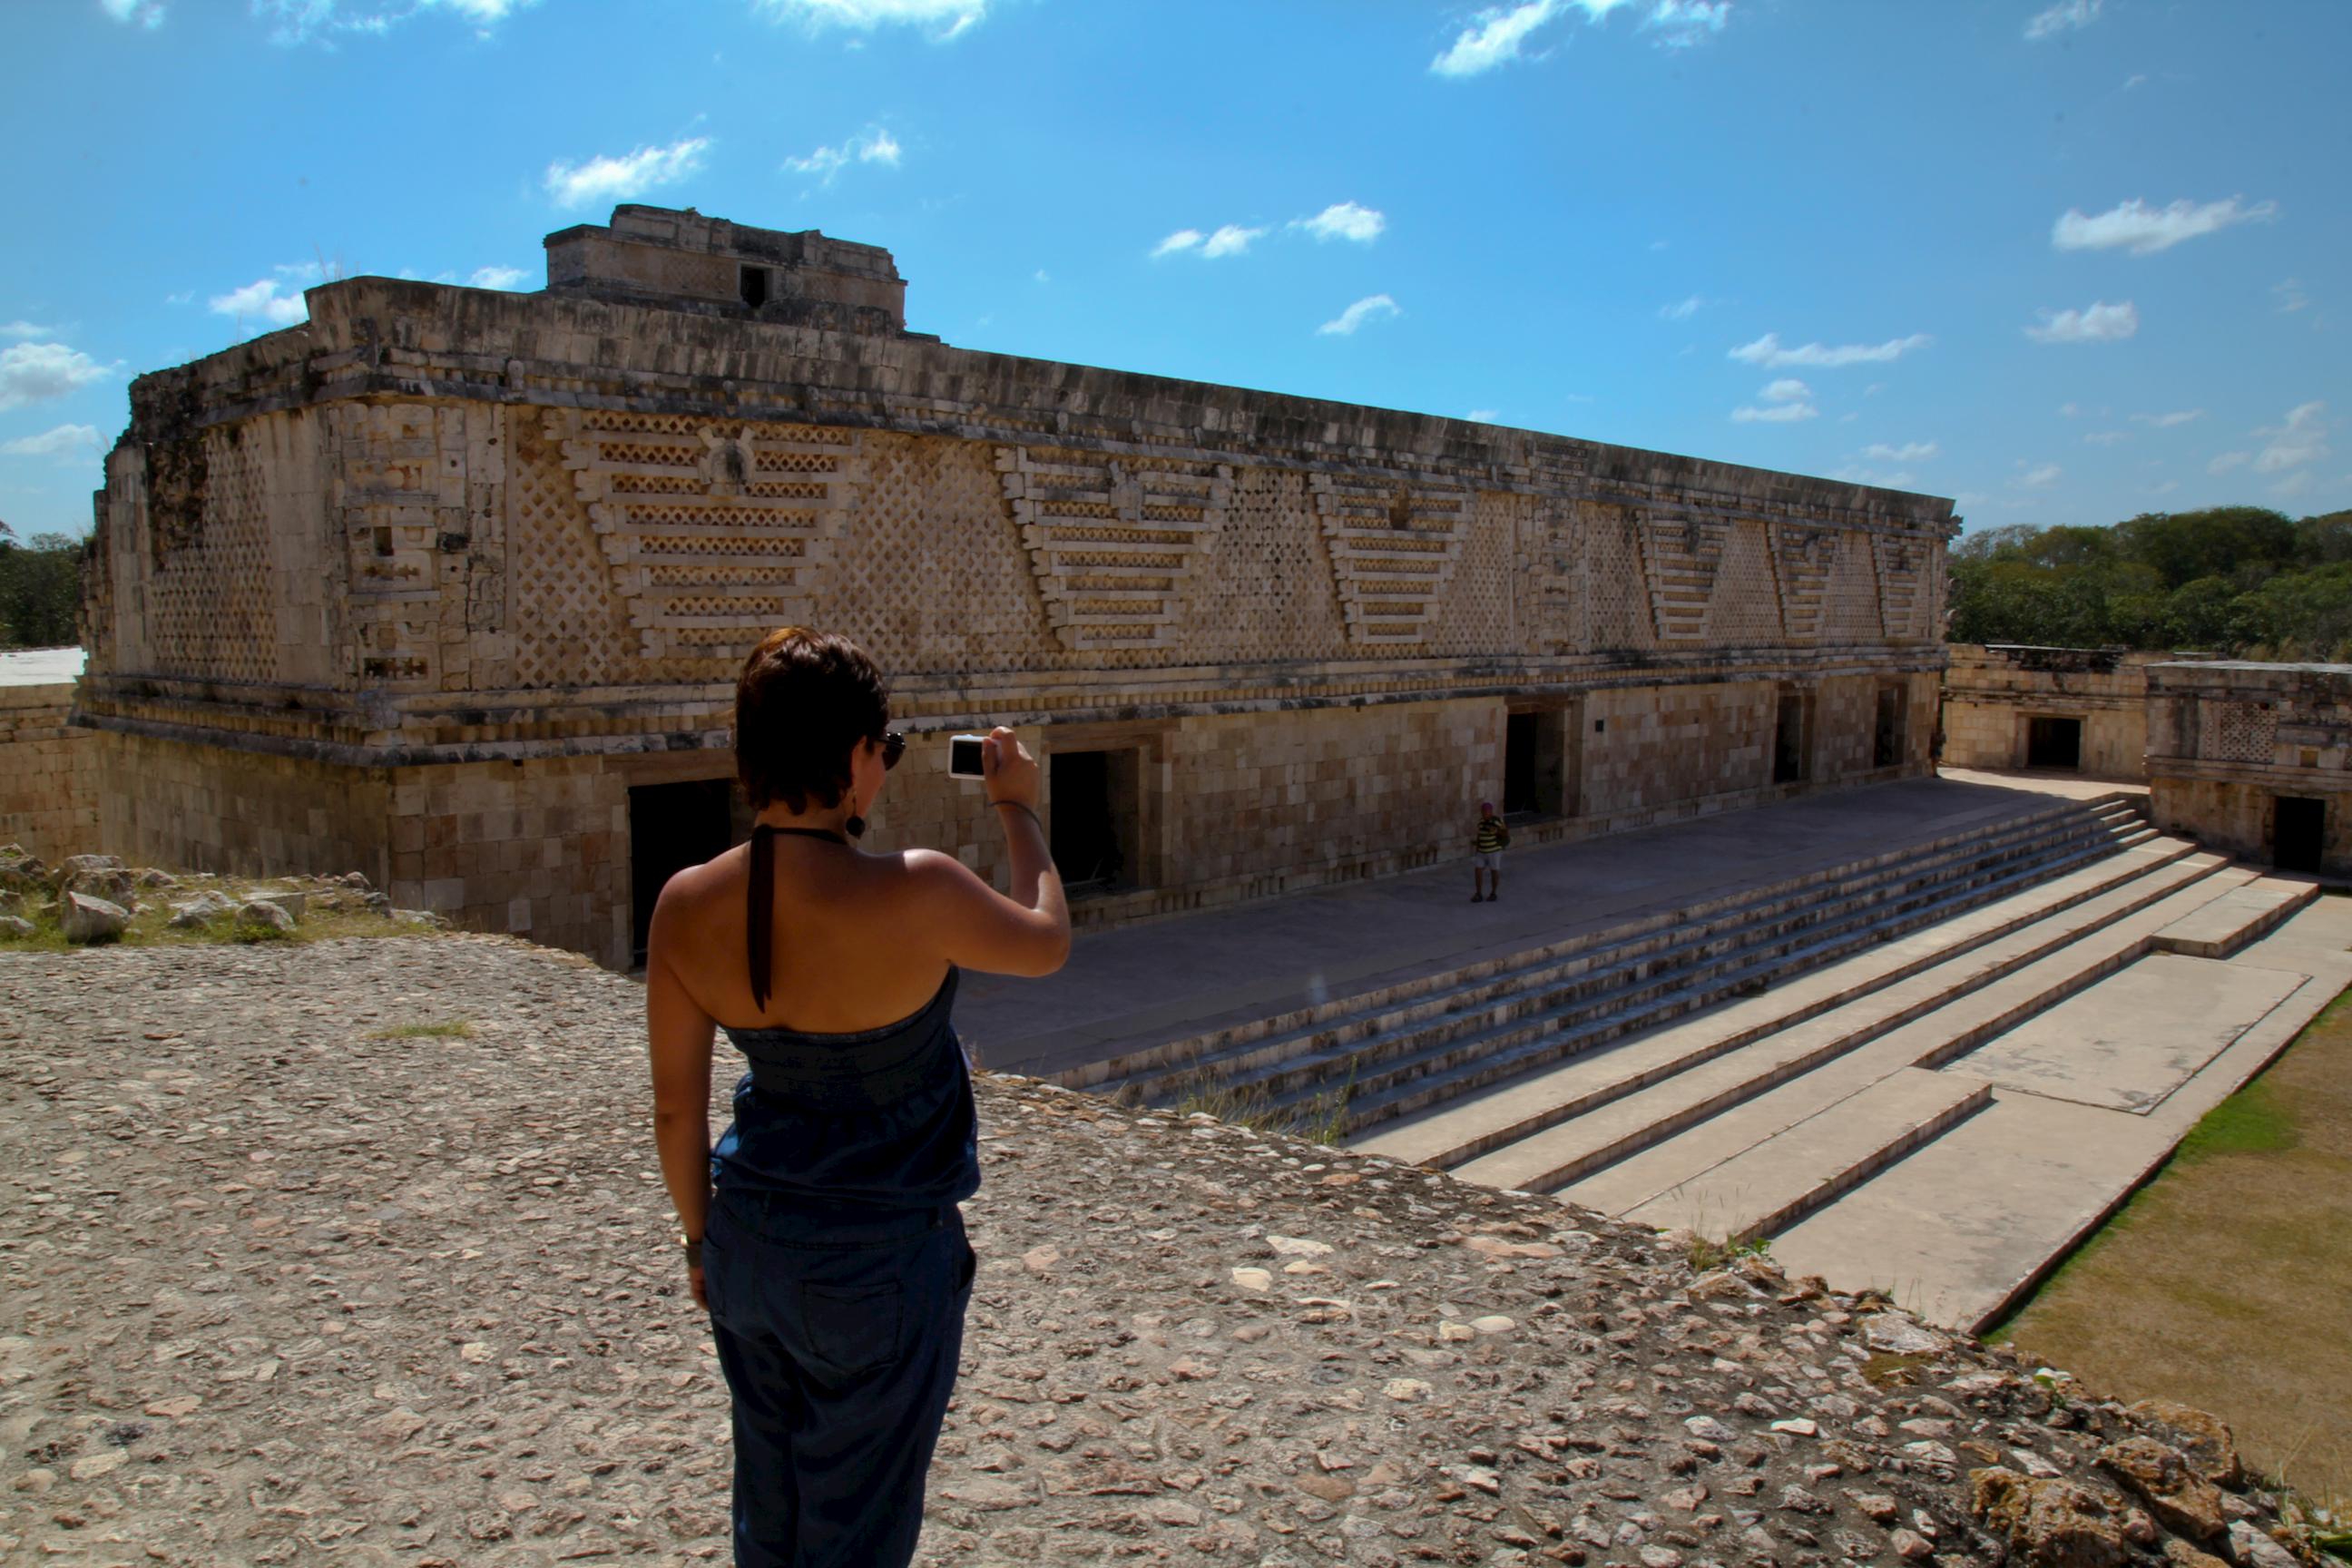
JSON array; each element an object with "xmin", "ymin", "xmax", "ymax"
[{"xmin": 75, "ymin": 207, "xmax": 1957, "ymax": 966}]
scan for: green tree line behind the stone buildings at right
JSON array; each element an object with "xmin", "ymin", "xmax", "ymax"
[{"xmin": 1947, "ymin": 505, "xmax": 2352, "ymax": 661}]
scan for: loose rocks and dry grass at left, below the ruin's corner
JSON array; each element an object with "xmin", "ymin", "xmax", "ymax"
[{"xmin": 0, "ymin": 844, "xmax": 446, "ymax": 945}]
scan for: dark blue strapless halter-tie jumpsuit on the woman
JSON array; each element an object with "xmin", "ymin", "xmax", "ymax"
[{"xmin": 703, "ymin": 827, "xmax": 981, "ymax": 1568}]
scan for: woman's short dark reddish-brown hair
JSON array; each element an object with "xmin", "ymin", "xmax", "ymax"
[{"xmin": 736, "ymin": 625, "xmax": 889, "ymax": 813}]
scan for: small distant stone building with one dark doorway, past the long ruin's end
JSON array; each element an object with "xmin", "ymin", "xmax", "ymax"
[{"xmin": 1943, "ymin": 644, "xmax": 2178, "ymax": 780}]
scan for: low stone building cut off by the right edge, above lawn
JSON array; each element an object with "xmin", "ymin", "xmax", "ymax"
[{"xmin": 2147, "ymin": 658, "xmax": 2352, "ymax": 877}]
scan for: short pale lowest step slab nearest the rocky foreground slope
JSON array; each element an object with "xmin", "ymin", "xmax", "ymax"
[{"xmin": 1608, "ymin": 1067, "xmax": 1992, "ymax": 1241}]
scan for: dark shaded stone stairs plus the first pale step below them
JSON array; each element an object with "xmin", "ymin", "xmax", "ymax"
[{"xmin": 1061, "ymin": 792, "xmax": 2154, "ymax": 1132}]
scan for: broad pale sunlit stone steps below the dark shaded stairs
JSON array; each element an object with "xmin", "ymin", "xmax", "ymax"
[{"xmin": 1352, "ymin": 835, "xmax": 2319, "ymax": 1298}]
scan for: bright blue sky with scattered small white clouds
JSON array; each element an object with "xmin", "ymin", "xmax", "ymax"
[{"xmin": 0, "ymin": 0, "xmax": 2352, "ymax": 536}]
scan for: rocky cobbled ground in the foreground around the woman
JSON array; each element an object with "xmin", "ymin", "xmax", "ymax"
[{"xmin": 0, "ymin": 936, "xmax": 2317, "ymax": 1568}]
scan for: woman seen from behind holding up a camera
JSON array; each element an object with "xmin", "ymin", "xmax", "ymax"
[{"xmin": 644, "ymin": 628, "xmax": 1070, "ymax": 1568}]
